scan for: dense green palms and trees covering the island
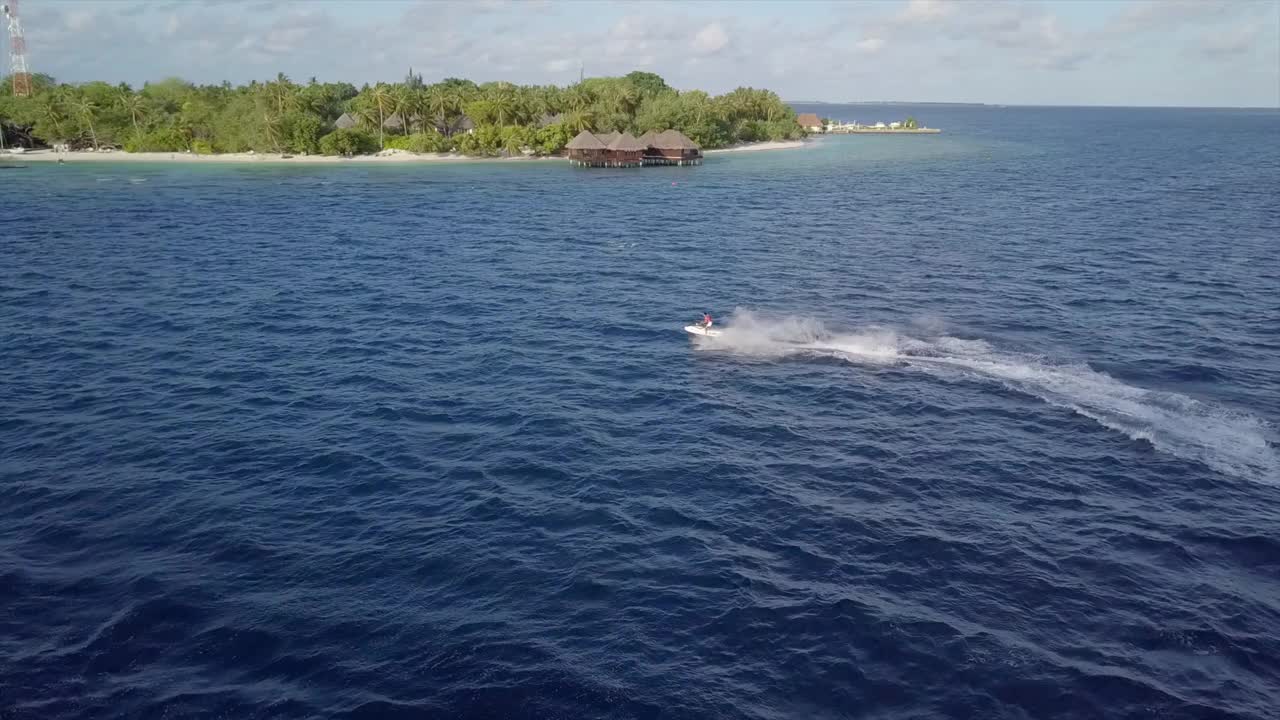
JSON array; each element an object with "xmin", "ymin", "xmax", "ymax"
[{"xmin": 0, "ymin": 72, "xmax": 804, "ymax": 156}]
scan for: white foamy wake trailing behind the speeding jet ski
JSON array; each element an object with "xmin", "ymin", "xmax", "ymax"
[{"xmin": 700, "ymin": 310, "xmax": 1280, "ymax": 484}]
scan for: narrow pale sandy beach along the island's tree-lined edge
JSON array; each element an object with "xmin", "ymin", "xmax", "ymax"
[{"xmin": 10, "ymin": 140, "xmax": 805, "ymax": 165}]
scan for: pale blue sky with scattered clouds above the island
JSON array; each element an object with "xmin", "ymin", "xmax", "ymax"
[{"xmin": 12, "ymin": 0, "xmax": 1280, "ymax": 108}]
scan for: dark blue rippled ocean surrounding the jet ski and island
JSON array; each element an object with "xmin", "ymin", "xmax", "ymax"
[{"xmin": 0, "ymin": 106, "xmax": 1280, "ymax": 720}]
